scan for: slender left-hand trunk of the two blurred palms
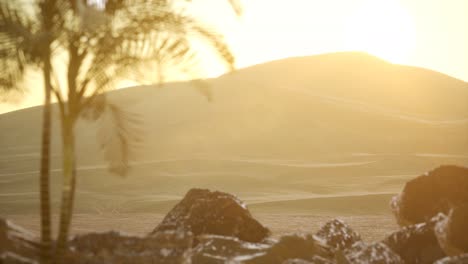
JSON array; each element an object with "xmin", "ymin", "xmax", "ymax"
[{"xmin": 39, "ymin": 50, "xmax": 52, "ymax": 264}]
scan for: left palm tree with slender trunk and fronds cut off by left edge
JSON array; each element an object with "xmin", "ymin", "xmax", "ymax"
[{"xmin": 0, "ymin": 0, "xmax": 62, "ymax": 263}]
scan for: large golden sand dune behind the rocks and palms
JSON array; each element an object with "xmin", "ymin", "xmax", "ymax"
[{"xmin": 0, "ymin": 53, "xmax": 468, "ymax": 215}]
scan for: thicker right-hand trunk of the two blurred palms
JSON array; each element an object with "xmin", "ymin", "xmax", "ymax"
[{"xmin": 56, "ymin": 115, "xmax": 75, "ymax": 263}]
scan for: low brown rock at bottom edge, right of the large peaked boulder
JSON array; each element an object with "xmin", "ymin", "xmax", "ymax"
[{"xmin": 244, "ymin": 235, "xmax": 333, "ymax": 264}]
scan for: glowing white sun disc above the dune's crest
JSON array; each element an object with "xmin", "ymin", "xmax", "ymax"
[{"xmin": 345, "ymin": 0, "xmax": 416, "ymax": 64}]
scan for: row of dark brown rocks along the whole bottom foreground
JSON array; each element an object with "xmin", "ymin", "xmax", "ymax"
[{"xmin": 0, "ymin": 177, "xmax": 468, "ymax": 264}]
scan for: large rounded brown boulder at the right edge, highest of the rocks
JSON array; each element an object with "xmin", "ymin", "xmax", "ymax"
[{"xmin": 390, "ymin": 165, "xmax": 468, "ymax": 226}]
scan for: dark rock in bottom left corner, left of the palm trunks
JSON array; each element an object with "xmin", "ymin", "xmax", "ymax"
[{"xmin": 0, "ymin": 218, "xmax": 39, "ymax": 263}]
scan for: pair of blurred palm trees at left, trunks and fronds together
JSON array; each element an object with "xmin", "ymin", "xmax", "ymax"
[{"xmin": 0, "ymin": 0, "xmax": 240, "ymax": 263}]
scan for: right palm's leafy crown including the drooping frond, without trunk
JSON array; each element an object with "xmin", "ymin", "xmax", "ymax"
[{"xmin": 64, "ymin": 0, "xmax": 241, "ymax": 175}]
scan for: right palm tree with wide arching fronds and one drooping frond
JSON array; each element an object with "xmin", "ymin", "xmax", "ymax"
[{"xmin": 42, "ymin": 0, "xmax": 239, "ymax": 260}]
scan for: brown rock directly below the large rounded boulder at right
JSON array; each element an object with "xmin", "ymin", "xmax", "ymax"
[{"xmin": 382, "ymin": 214, "xmax": 445, "ymax": 264}]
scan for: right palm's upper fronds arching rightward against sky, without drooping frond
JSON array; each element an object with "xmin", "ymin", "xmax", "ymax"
[{"xmin": 69, "ymin": 0, "xmax": 235, "ymax": 99}]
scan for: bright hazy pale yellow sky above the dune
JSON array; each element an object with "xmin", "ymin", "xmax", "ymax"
[{"xmin": 0, "ymin": 0, "xmax": 468, "ymax": 113}]
